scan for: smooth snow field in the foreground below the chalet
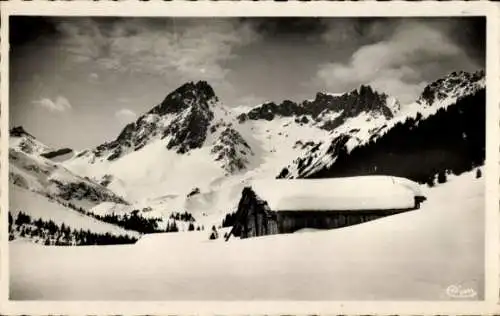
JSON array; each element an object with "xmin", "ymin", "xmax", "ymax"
[{"xmin": 10, "ymin": 173, "xmax": 484, "ymax": 300}]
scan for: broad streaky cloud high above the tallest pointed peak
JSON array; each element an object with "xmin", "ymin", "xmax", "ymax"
[{"xmin": 59, "ymin": 18, "xmax": 258, "ymax": 81}]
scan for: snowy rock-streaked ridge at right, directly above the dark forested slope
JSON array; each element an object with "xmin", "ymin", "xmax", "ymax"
[{"xmin": 279, "ymin": 71, "xmax": 485, "ymax": 178}]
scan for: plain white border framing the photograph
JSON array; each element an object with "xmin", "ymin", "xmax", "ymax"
[{"xmin": 0, "ymin": 1, "xmax": 500, "ymax": 315}]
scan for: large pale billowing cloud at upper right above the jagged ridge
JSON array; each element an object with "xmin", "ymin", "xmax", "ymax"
[{"xmin": 317, "ymin": 22, "xmax": 476, "ymax": 102}]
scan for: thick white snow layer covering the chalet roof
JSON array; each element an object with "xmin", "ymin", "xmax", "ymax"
[{"xmin": 251, "ymin": 176, "xmax": 422, "ymax": 211}]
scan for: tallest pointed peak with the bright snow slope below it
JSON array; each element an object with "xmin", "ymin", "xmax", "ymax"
[{"xmin": 64, "ymin": 81, "xmax": 253, "ymax": 201}]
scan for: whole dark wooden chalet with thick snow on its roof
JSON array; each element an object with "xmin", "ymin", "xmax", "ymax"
[{"xmin": 226, "ymin": 176, "xmax": 425, "ymax": 240}]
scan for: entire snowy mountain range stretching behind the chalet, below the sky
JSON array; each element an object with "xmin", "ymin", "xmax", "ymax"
[{"xmin": 11, "ymin": 71, "xmax": 485, "ymax": 231}]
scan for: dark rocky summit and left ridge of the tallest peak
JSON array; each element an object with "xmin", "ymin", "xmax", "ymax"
[{"xmin": 84, "ymin": 81, "xmax": 218, "ymax": 161}]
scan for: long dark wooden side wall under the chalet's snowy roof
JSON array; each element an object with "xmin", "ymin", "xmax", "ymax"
[{"xmin": 278, "ymin": 209, "xmax": 410, "ymax": 234}]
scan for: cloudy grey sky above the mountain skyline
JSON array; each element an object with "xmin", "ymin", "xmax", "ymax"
[{"xmin": 10, "ymin": 17, "xmax": 485, "ymax": 149}]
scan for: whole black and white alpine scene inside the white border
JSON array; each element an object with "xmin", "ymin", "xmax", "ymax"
[{"xmin": 2, "ymin": 1, "xmax": 498, "ymax": 314}]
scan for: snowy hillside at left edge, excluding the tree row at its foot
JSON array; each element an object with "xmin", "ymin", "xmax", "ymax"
[{"xmin": 9, "ymin": 127, "xmax": 132, "ymax": 233}]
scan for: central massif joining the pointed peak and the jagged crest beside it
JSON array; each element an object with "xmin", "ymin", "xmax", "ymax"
[{"xmin": 65, "ymin": 81, "xmax": 399, "ymax": 200}]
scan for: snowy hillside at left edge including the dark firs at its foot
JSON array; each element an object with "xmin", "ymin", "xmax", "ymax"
[{"xmin": 9, "ymin": 127, "xmax": 140, "ymax": 245}]
